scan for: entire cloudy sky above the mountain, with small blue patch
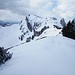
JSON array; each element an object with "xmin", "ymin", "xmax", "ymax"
[{"xmin": 0, "ymin": 0, "xmax": 75, "ymax": 21}]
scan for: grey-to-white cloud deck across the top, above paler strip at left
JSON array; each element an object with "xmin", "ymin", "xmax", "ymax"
[{"xmin": 0, "ymin": 0, "xmax": 75, "ymax": 17}]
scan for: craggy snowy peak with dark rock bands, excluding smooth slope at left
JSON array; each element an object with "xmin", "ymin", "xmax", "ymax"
[{"xmin": 19, "ymin": 15, "xmax": 60, "ymax": 42}]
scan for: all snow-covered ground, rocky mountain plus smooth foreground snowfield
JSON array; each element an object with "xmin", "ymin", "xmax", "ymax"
[{"xmin": 0, "ymin": 15, "xmax": 75, "ymax": 75}]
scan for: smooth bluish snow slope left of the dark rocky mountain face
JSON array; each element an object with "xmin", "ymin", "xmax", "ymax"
[{"xmin": 0, "ymin": 24, "xmax": 20, "ymax": 48}]
